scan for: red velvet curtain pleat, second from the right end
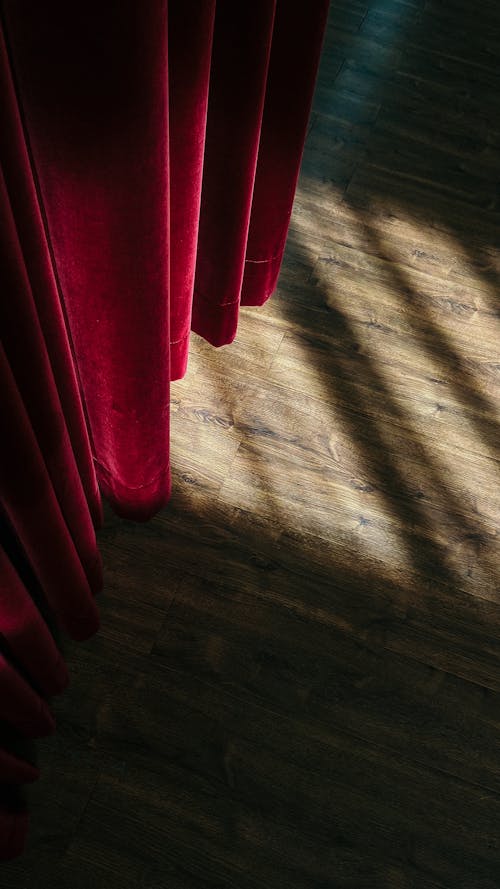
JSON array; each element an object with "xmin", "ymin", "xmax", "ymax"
[{"xmin": 191, "ymin": 0, "xmax": 276, "ymax": 346}]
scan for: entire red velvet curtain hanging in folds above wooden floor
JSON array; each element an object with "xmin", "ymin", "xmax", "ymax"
[{"xmin": 0, "ymin": 0, "xmax": 328, "ymax": 858}]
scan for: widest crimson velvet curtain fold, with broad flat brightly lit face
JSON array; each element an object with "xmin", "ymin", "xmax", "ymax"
[{"xmin": 4, "ymin": 0, "xmax": 173, "ymax": 518}]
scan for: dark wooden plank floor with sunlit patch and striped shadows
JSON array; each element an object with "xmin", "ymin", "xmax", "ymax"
[{"xmin": 0, "ymin": 0, "xmax": 500, "ymax": 889}]
